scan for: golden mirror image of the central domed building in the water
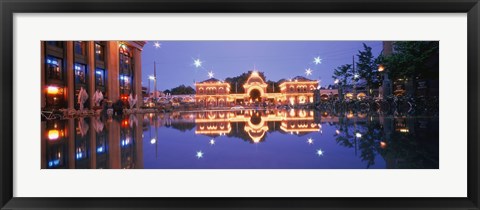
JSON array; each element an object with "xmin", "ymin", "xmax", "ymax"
[{"xmin": 195, "ymin": 109, "xmax": 320, "ymax": 143}]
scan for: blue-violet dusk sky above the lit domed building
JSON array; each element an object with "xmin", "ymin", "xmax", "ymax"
[{"xmin": 142, "ymin": 40, "xmax": 382, "ymax": 90}]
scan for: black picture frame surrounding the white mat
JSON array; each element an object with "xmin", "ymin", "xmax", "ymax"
[{"xmin": 0, "ymin": 0, "xmax": 480, "ymax": 209}]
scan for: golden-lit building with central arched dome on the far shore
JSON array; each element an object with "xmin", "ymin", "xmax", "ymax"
[{"xmin": 195, "ymin": 71, "xmax": 318, "ymax": 107}]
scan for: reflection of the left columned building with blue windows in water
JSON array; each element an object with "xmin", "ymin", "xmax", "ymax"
[{"xmin": 41, "ymin": 115, "xmax": 143, "ymax": 169}]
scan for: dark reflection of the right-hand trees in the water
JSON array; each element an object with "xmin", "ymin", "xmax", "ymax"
[{"xmin": 334, "ymin": 113, "xmax": 439, "ymax": 169}]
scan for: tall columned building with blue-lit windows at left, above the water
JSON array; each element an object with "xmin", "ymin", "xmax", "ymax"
[{"xmin": 41, "ymin": 41, "xmax": 146, "ymax": 109}]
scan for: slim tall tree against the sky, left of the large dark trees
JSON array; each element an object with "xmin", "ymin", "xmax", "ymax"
[{"xmin": 354, "ymin": 43, "xmax": 380, "ymax": 95}]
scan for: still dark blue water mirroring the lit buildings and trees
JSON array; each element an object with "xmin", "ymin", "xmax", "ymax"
[{"xmin": 41, "ymin": 109, "xmax": 439, "ymax": 169}]
